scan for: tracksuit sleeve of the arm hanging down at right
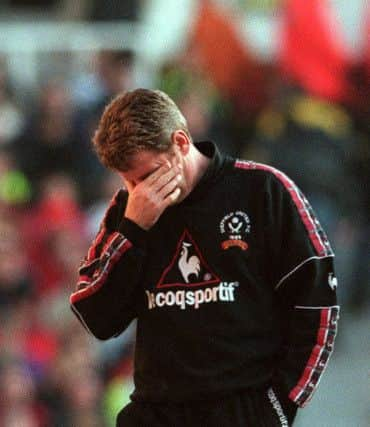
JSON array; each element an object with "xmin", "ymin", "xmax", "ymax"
[{"xmin": 268, "ymin": 172, "xmax": 339, "ymax": 407}]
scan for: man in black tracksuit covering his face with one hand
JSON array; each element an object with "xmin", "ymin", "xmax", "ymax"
[{"xmin": 71, "ymin": 89, "xmax": 339, "ymax": 427}]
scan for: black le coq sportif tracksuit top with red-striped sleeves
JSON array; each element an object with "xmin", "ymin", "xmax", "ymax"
[{"xmin": 70, "ymin": 142, "xmax": 339, "ymax": 406}]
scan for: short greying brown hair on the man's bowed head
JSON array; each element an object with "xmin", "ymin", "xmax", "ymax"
[{"xmin": 93, "ymin": 89, "xmax": 190, "ymax": 172}]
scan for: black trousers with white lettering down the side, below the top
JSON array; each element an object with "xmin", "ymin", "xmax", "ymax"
[{"xmin": 117, "ymin": 386, "xmax": 297, "ymax": 427}]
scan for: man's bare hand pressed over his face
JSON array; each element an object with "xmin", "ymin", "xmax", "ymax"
[{"xmin": 125, "ymin": 162, "xmax": 182, "ymax": 230}]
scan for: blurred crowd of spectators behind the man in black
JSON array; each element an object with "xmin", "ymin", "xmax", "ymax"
[{"xmin": 0, "ymin": 2, "xmax": 370, "ymax": 427}]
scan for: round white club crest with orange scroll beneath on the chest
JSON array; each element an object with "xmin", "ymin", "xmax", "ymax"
[{"xmin": 220, "ymin": 211, "xmax": 251, "ymax": 251}]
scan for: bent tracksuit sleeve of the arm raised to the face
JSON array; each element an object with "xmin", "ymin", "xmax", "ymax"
[{"xmin": 70, "ymin": 192, "xmax": 146, "ymax": 340}]
